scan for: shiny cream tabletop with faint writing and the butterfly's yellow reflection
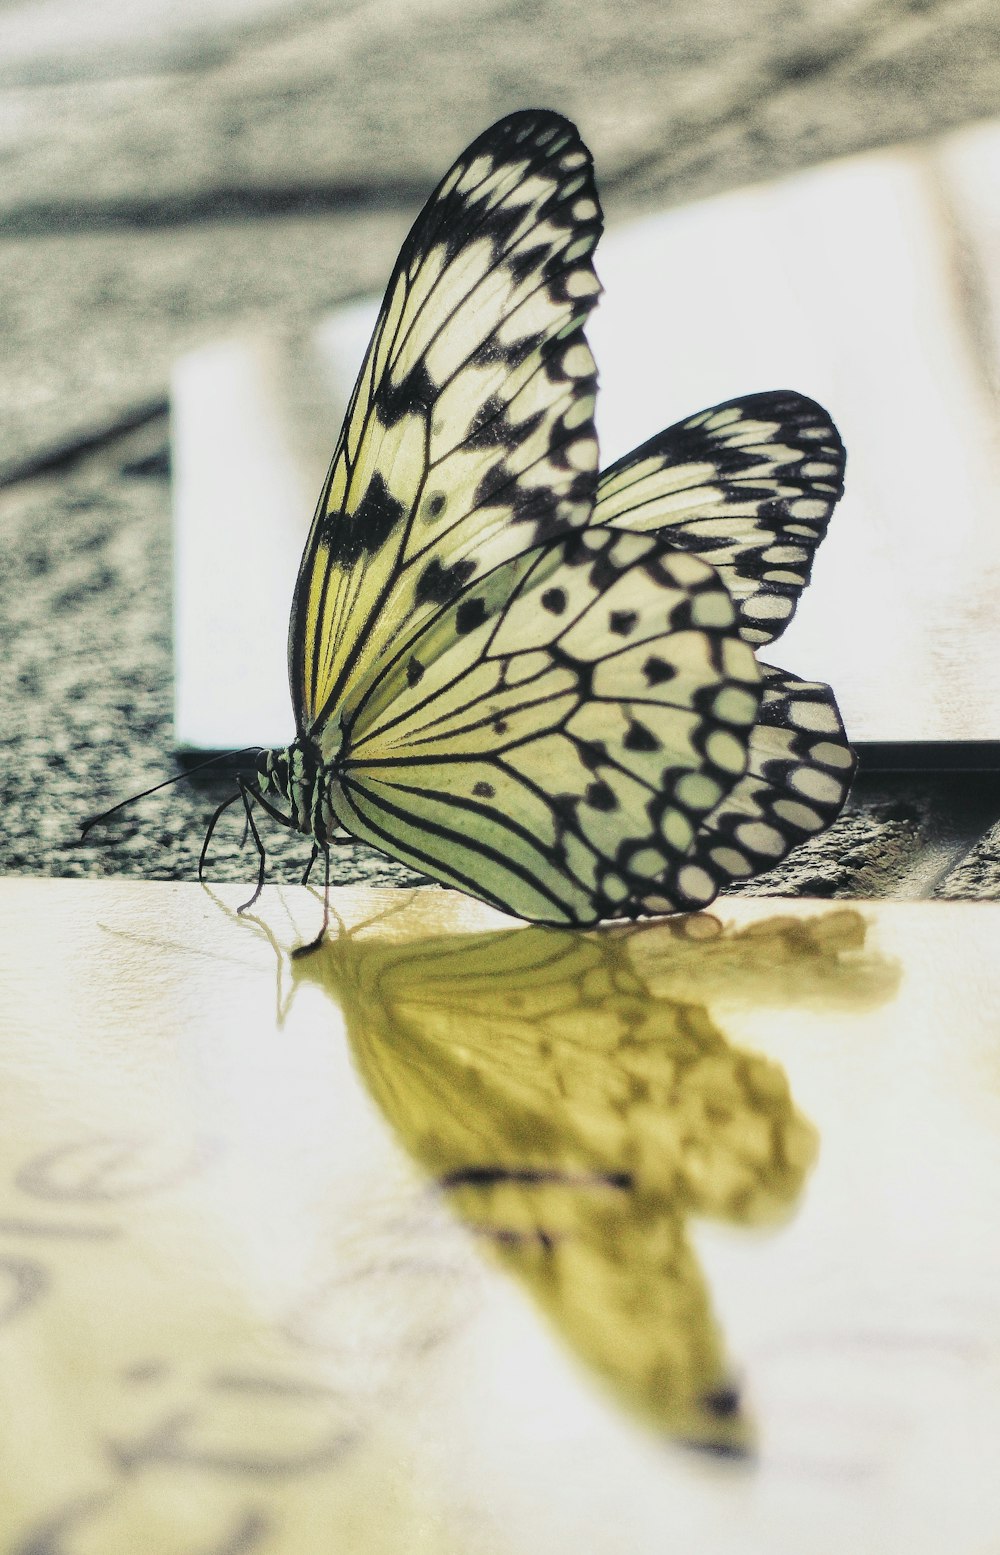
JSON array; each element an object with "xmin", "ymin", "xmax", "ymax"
[{"xmin": 0, "ymin": 880, "xmax": 1000, "ymax": 1555}]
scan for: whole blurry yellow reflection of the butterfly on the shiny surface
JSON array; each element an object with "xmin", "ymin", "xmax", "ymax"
[{"xmin": 283, "ymin": 910, "xmax": 893, "ymax": 1452}]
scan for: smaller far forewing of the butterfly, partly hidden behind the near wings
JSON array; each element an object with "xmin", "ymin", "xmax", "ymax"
[{"xmin": 594, "ymin": 390, "xmax": 844, "ymax": 645}]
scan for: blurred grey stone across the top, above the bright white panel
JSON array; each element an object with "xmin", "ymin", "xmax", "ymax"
[{"xmin": 0, "ymin": 0, "xmax": 1000, "ymax": 479}]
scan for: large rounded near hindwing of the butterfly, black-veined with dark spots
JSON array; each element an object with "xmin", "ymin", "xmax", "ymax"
[{"xmin": 331, "ymin": 527, "xmax": 759, "ymax": 924}]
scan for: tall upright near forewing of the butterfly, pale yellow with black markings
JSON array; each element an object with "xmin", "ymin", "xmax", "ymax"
[{"xmin": 289, "ymin": 110, "xmax": 600, "ymax": 759}]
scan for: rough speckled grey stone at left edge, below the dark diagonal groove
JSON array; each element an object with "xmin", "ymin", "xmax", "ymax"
[{"xmin": 0, "ymin": 418, "xmax": 415, "ymax": 883}]
